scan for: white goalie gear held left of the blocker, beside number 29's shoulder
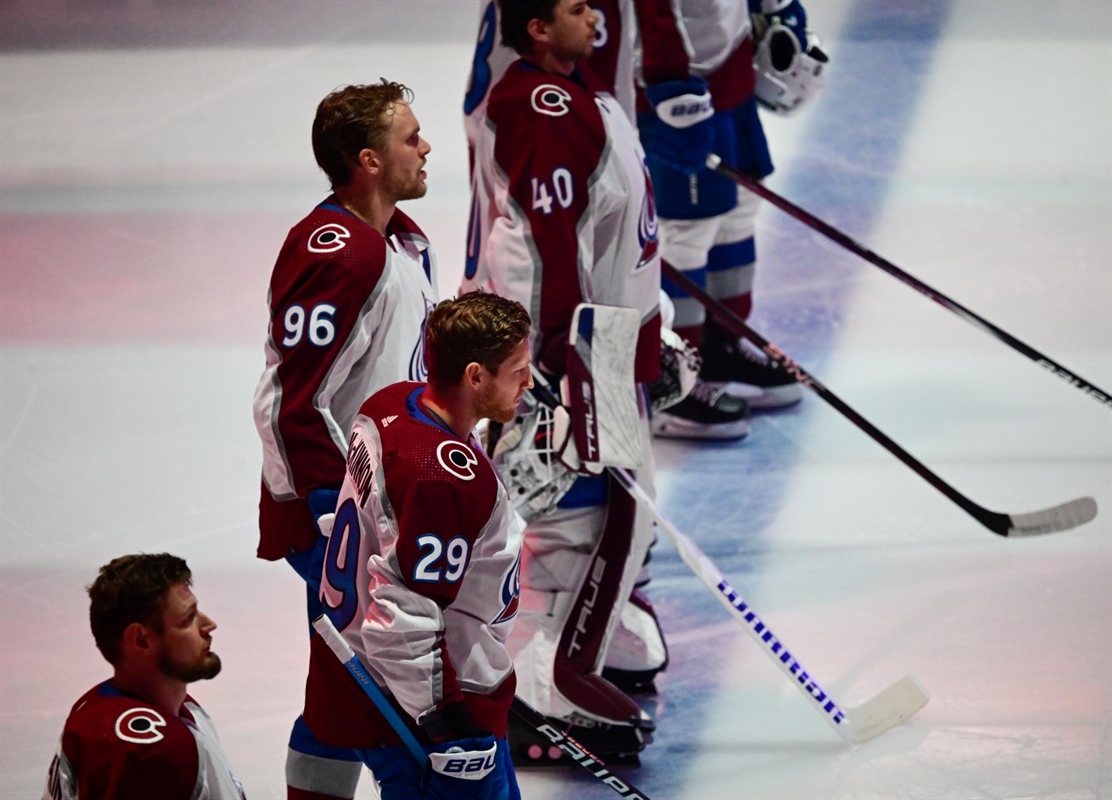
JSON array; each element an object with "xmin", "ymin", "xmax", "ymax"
[{"xmin": 493, "ymin": 394, "xmax": 584, "ymax": 522}]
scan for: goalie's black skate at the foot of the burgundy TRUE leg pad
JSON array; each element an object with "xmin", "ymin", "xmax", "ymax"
[{"xmin": 506, "ymin": 712, "xmax": 656, "ymax": 769}]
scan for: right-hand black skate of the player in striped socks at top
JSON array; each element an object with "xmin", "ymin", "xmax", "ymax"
[{"xmin": 699, "ymin": 330, "xmax": 803, "ymax": 409}]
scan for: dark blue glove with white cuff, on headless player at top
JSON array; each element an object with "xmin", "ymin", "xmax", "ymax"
[{"xmin": 645, "ymin": 78, "xmax": 714, "ymax": 175}]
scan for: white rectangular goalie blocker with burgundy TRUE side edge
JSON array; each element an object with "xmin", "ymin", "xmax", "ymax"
[{"xmin": 566, "ymin": 303, "xmax": 642, "ymax": 467}]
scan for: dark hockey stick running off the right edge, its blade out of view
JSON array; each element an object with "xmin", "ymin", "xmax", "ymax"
[{"xmin": 706, "ymin": 152, "xmax": 1112, "ymax": 408}]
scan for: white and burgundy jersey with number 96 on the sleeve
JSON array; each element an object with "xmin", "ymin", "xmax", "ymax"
[{"xmin": 255, "ymin": 197, "xmax": 437, "ymax": 560}]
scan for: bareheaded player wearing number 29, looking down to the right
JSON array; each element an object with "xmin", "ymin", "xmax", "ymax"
[{"xmin": 304, "ymin": 293, "xmax": 533, "ymax": 800}]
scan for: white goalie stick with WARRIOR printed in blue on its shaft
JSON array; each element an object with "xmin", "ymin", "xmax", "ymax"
[{"xmin": 524, "ymin": 367, "xmax": 930, "ymax": 743}]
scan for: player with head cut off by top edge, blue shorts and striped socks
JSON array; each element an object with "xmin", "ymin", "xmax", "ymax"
[{"xmin": 638, "ymin": 0, "xmax": 825, "ymax": 436}]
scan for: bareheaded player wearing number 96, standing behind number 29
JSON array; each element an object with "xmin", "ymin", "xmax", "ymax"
[{"xmin": 255, "ymin": 80, "xmax": 437, "ymax": 799}]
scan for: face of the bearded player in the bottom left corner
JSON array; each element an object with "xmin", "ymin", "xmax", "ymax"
[{"xmin": 158, "ymin": 583, "xmax": 220, "ymax": 683}]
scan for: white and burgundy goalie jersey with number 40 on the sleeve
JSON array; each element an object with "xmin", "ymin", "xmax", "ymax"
[{"xmin": 464, "ymin": 59, "xmax": 661, "ymax": 381}]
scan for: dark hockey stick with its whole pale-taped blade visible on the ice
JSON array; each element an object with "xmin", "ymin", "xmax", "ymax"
[{"xmin": 661, "ymin": 261, "xmax": 1096, "ymax": 536}]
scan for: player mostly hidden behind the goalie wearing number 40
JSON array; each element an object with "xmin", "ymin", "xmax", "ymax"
[{"xmin": 464, "ymin": 0, "xmax": 748, "ymax": 438}]
